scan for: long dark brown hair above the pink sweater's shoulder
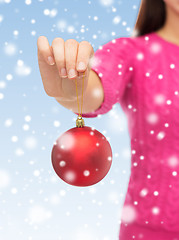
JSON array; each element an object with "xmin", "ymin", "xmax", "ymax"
[{"xmin": 134, "ymin": 0, "xmax": 166, "ymax": 36}]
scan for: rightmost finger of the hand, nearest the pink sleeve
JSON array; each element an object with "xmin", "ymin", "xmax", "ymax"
[{"xmin": 77, "ymin": 41, "xmax": 94, "ymax": 72}]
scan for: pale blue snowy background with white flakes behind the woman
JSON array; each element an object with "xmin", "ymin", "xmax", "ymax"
[{"xmin": 0, "ymin": 0, "xmax": 140, "ymax": 240}]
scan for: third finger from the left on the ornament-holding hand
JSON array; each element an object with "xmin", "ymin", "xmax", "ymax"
[{"xmin": 65, "ymin": 39, "xmax": 79, "ymax": 79}]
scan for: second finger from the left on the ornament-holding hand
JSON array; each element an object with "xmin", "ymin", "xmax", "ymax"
[{"xmin": 52, "ymin": 38, "xmax": 67, "ymax": 78}]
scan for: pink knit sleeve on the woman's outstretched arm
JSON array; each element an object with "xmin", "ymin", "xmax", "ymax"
[{"xmin": 75, "ymin": 37, "xmax": 132, "ymax": 117}]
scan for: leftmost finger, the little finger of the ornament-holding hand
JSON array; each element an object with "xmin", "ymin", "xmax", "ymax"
[{"xmin": 37, "ymin": 36, "xmax": 55, "ymax": 65}]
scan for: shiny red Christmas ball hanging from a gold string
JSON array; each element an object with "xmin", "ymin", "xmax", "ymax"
[{"xmin": 51, "ymin": 126, "xmax": 112, "ymax": 187}]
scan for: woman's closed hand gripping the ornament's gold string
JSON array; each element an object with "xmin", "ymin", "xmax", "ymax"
[{"xmin": 37, "ymin": 36, "xmax": 94, "ymax": 101}]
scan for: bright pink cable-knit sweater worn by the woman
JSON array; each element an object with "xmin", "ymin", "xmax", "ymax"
[{"xmin": 75, "ymin": 32, "xmax": 179, "ymax": 240}]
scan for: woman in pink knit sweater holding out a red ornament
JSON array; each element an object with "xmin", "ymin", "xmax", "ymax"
[{"xmin": 37, "ymin": 0, "xmax": 179, "ymax": 240}]
